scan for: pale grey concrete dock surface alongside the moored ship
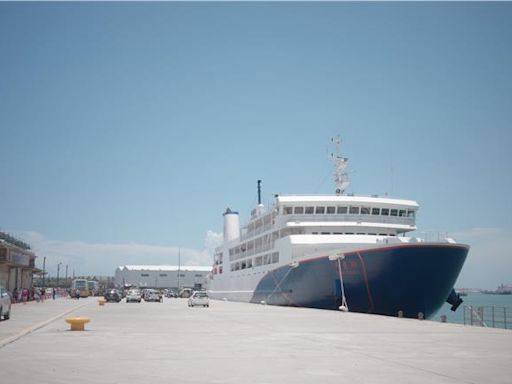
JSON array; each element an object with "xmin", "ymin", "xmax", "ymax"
[{"xmin": 0, "ymin": 298, "xmax": 512, "ymax": 384}]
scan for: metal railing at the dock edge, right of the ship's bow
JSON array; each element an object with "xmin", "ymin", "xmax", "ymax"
[{"xmin": 464, "ymin": 305, "xmax": 512, "ymax": 329}]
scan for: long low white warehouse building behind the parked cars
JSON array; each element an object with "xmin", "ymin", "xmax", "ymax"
[{"xmin": 115, "ymin": 265, "xmax": 212, "ymax": 290}]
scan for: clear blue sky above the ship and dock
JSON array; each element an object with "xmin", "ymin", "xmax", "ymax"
[{"xmin": 0, "ymin": 3, "xmax": 512, "ymax": 287}]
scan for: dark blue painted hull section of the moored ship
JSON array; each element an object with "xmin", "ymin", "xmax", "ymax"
[{"xmin": 251, "ymin": 244, "xmax": 469, "ymax": 318}]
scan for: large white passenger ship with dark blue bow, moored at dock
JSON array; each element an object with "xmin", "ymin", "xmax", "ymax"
[{"xmin": 208, "ymin": 138, "xmax": 469, "ymax": 318}]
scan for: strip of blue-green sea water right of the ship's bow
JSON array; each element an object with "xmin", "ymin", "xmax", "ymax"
[{"xmin": 430, "ymin": 292, "xmax": 512, "ymax": 328}]
